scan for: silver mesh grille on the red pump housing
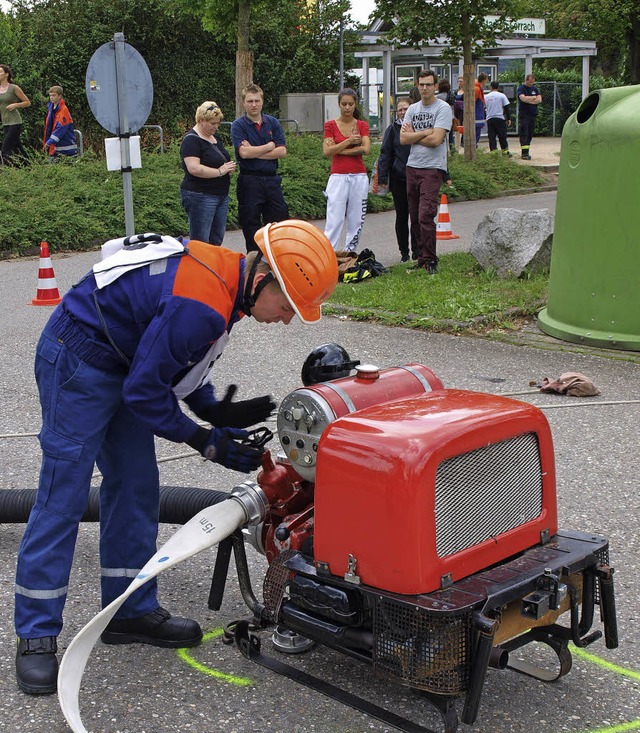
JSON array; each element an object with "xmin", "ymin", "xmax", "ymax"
[{"xmin": 435, "ymin": 433, "xmax": 542, "ymax": 557}]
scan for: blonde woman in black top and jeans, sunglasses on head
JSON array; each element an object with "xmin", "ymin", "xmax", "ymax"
[{"xmin": 180, "ymin": 102, "xmax": 236, "ymax": 245}]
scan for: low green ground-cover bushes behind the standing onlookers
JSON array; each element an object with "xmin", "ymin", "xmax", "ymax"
[{"xmin": 0, "ymin": 135, "xmax": 540, "ymax": 257}]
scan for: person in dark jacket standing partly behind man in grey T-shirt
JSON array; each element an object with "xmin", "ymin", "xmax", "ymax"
[{"xmin": 378, "ymin": 99, "xmax": 417, "ymax": 262}]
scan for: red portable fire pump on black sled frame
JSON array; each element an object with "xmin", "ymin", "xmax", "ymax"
[{"xmin": 209, "ymin": 364, "xmax": 618, "ymax": 733}]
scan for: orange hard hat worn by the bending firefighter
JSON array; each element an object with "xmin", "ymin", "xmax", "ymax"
[{"xmin": 255, "ymin": 219, "xmax": 338, "ymax": 323}]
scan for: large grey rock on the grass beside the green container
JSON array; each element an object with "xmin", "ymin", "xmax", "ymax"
[{"xmin": 471, "ymin": 209, "xmax": 553, "ymax": 277}]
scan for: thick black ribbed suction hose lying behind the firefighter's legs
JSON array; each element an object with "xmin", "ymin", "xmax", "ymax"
[{"xmin": 0, "ymin": 486, "xmax": 229, "ymax": 524}]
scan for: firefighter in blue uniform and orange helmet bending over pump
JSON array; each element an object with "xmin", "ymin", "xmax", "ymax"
[{"xmin": 15, "ymin": 220, "xmax": 338, "ymax": 694}]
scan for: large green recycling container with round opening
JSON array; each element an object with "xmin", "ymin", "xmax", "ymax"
[{"xmin": 538, "ymin": 86, "xmax": 640, "ymax": 351}]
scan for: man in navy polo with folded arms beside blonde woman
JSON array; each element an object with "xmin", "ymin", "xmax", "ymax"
[{"xmin": 231, "ymin": 84, "xmax": 289, "ymax": 252}]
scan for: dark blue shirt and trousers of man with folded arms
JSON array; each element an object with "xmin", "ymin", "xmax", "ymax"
[{"xmin": 231, "ymin": 114, "xmax": 289, "ymax": 252}]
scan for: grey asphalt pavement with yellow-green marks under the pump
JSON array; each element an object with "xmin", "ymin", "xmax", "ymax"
[{"xmin": 0, "ymin": 192, "xmax": 640, "ymax": 733}]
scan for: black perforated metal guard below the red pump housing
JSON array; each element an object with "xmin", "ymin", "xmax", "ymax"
[{"xmin": 373, "ymin": 597, "xmax": 471, "ymax": 695}]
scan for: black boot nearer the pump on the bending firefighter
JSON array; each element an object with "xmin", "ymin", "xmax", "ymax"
[{"xmin": 100, "ymin": 606, "xmax": 202, "ymax": 649}]
